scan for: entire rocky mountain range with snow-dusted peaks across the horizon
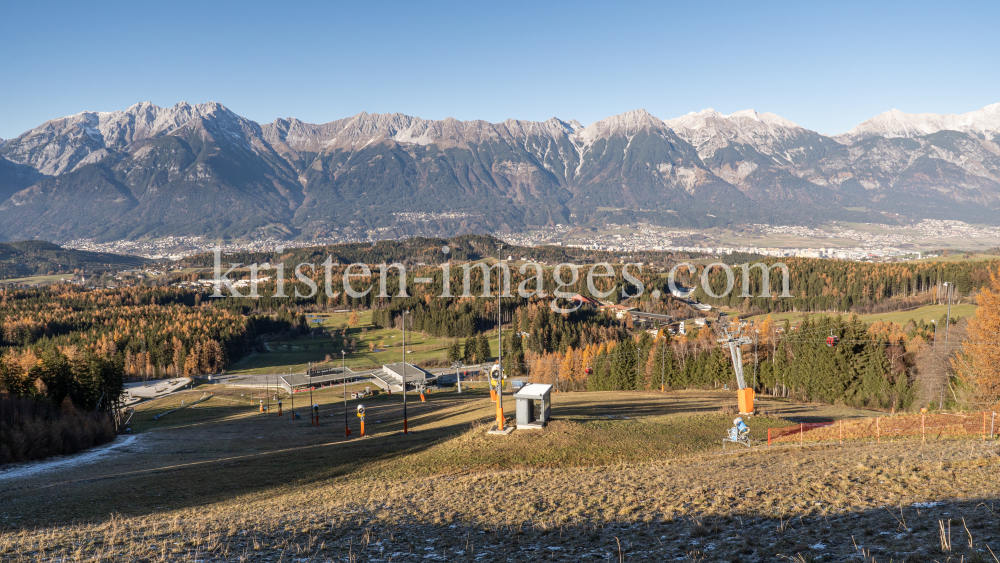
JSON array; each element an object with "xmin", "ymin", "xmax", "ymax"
[{"xmin": 0, "ymin": 102, "xmax": 1000, "ymax": 241}]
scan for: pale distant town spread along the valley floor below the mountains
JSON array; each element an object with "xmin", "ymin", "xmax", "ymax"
[{"xmin": 63, "ymin": 219, "xmax": 1000, "ymax": 261}]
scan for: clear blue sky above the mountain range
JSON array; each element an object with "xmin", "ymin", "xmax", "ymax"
[{"xmin": 0, "ymin": 0, "xmax": 1000, "ymax": 138}]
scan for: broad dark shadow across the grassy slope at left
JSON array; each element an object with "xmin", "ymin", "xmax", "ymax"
[{"xmin": 0, "ymin": 393, "xmax": 500, "ymax": 529}]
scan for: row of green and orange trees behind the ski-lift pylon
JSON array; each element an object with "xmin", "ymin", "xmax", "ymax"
[{"xmin": 525, "ymin": 316, "xmax": 933, "ymax": 409}]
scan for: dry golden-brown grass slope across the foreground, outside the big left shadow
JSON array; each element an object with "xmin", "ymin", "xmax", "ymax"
[{"xmin": 0, "ymin": 386, "xmax": 1000, "ymax": 562}]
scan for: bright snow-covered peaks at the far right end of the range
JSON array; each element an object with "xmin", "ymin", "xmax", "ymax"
[{"xmin": 835, "ymin": 103, "xmax": 1000, "ymax": 143}]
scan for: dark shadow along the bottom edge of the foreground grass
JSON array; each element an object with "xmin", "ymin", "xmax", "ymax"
[{"xmin": 201, "ymin": 497, "xmax": 1000, "ymax": 563}]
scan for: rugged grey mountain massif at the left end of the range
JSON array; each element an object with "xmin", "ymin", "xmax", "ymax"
[{"xmin": 0, "ymin": 103, "xmax": 303, "ymax": 240}]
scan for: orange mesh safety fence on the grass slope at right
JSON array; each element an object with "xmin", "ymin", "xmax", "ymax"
[{"xmin": 767, "ymin": 412, "xmax": 1000, "ymax": 446}]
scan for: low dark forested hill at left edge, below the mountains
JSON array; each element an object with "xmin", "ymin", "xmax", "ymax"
[{"xmin": 0, "ymin": 240, "xmax": 144, "ymax": 279}]
